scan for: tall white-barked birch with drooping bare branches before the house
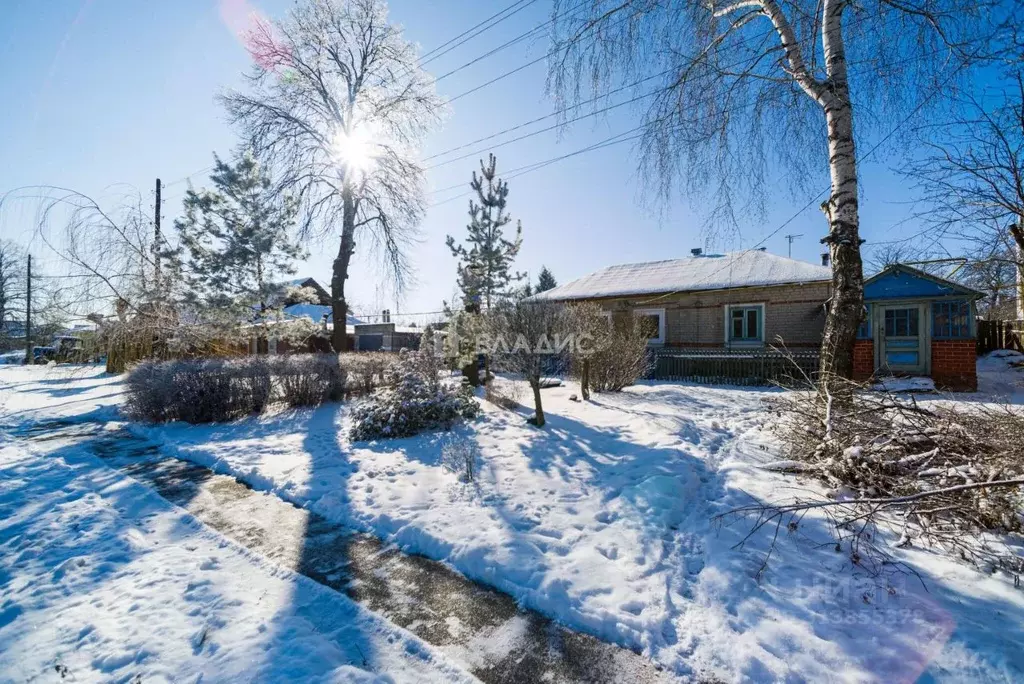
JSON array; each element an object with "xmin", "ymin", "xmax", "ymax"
[{"xmin": 549, "ymin": 0, "xmax": 994, "ymax": 384}]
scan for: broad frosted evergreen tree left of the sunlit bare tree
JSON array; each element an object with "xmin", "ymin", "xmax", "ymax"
[{"xmin": 175, "ymin": 154, "xmax": 303, "ymax": 312}]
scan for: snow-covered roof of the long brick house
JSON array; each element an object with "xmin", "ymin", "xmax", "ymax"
[{"xmin": 530, "ymin": 250, "xmax": 831, "ymax": 301}]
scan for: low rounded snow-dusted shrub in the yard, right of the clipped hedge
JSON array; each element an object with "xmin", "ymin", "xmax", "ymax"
[{"xmin": 350, "ymin": 352, "xmax": 480, "ymax": 440}]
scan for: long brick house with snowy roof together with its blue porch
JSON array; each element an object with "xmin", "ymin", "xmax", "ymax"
[{"xmin": 531, "ymin": 250, "xmax": 981, "ymax": 390}]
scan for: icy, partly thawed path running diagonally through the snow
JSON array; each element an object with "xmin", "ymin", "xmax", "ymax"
[{"xmin": 31, "ymin": 424, "xmax": 663, "ymax": 684}]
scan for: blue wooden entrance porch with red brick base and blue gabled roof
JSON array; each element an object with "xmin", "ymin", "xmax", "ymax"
[{"xmin": 853, "ymin": 264, "xmax": 984, "ymax": 391}]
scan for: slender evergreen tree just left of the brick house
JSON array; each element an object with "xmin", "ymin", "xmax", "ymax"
[{"xmin": 447, "ymin": 155, "xmax": 523, "ymax": 309}]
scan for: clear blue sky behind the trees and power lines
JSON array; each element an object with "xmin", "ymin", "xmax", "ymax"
[{"xmin": 0, "ymin": 0, "xmax": 950, "ymax": 321}]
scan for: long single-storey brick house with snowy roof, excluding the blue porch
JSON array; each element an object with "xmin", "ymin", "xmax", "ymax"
[{"xmin": 532, "ymin": 250, "xmax": 831, "ymax": 349}]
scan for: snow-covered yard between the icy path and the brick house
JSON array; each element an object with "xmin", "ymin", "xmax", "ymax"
[{"xmin": 0, "ymin": 359, "xmax": 1024, "ymax": 682}]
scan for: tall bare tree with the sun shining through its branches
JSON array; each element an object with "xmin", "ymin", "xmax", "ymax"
[{"xmin": 221, "ymin": 0, "xmax": 441, "ymax": 351}]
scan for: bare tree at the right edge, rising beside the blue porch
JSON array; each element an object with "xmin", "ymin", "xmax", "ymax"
[{"xmin": 907, "ymin": 72, "xmax": 1024, "ymax": 317}]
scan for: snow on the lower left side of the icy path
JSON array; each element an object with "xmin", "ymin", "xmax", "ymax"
[{"xmin": 0, "ymin": 369, "xmax": 475, "ymax": 682}]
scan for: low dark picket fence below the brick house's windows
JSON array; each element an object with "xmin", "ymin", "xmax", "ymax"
[{"xmin": 651, "ymin": 349, "xmax": 818, "ymax": 386}]
